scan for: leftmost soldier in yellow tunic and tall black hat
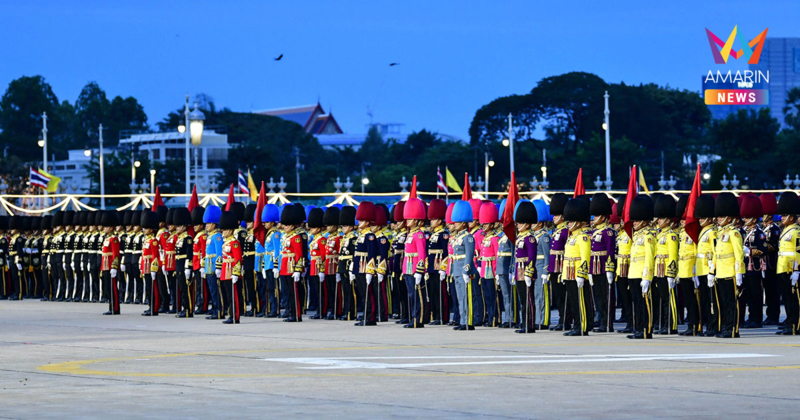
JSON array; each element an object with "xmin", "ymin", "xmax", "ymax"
[{"xmin": 561, "ymin": 198, "xmax": 594, "ymax": 337}]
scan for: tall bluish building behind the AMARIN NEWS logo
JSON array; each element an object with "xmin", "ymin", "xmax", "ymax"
[{"xmin": 752, "ymin": 38, "xmax": 800, "ymax": 127}]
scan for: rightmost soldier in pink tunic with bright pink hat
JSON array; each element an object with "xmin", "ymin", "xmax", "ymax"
[{"xmin": 478, "ymin": 203, "xmax": 500, "ymax": 327}]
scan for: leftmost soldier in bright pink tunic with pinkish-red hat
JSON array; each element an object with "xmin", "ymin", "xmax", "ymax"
[{"xmin": 403, "ymin": 198, "xmax": 428, "ymax": 328}]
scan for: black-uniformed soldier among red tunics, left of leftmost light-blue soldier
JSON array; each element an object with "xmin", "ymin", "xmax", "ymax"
[{"xmin": 172, "ymin": 207, "xmax": 196, "ymax": 318}]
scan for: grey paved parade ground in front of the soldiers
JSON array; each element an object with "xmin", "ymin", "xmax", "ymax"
[{"xmin": 0, "ymin": 300, "xmax": 800, "ymax": 419}]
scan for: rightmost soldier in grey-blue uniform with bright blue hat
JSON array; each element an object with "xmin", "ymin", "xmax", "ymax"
[{"xmin": 531, "ymin": 200, "xmax": 552, "ymax": 331}]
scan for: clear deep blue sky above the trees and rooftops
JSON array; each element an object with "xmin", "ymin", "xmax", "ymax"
[{"xmin": 0, "ymin": 0, "xmax": 800, "ymax": 142}]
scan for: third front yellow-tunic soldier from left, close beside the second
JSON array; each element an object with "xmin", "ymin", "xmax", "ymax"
[{"xmin": 653, "ymin": 195, "xmax": 678, "ymax": 334}]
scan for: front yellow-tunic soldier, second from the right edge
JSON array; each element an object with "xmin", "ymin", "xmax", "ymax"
[{"xmin": 708, "ymin": 192, "xmax": 746, "ymax": 338}]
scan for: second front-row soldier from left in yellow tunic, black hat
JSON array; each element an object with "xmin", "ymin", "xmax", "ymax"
[{"xmin": 628, "ymin": 195, "xmax": 656, "ymax": 339}]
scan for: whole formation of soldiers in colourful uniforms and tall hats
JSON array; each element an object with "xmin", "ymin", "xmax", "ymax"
[{"xmin": 0, "ymin": 192, "xmax": 800, "ymax": 339}]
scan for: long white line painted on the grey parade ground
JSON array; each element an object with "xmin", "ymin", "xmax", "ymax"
[{"xmin": 261, "ymin": 353, "xmax": 774, "ymax": 369}]
